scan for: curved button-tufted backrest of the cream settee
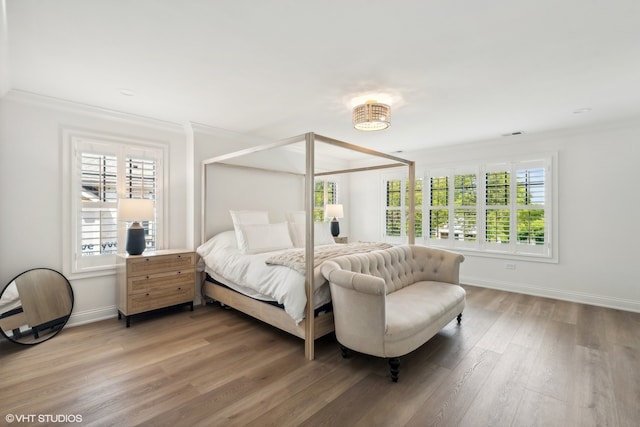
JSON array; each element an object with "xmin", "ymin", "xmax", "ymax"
[{"xmin": 332, "ymin": 245, "xmax": 464, "ymax": 294}]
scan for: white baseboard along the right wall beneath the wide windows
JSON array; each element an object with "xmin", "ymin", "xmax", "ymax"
[{"xmin": 460, "ymin": 277, "xmax": 640, "ymax": 313}]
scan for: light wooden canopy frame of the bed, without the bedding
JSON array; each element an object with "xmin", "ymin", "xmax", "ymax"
[{"xmin": 201, "ymin": 132, "xmax": 415, "ymax": 360}]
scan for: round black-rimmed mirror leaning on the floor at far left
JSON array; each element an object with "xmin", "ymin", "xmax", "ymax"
[{"xmin": 0, "ymin": 268, "xmax": 73, "ymax": 344}]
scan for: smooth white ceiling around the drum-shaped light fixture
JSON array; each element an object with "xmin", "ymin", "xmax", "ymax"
[{"xmin": 0, "ymin": 0, "xmax": 640, "ymax": 152}]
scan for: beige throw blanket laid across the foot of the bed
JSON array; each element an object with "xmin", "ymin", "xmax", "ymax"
[{"xmin": 265, "ymin": 242, "xmax": 392, "ymax": 275}]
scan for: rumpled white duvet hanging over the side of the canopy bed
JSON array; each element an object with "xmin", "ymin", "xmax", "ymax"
[{"xmin": 197, "ymin": 230, "xmax": 331, "ymax": 323}]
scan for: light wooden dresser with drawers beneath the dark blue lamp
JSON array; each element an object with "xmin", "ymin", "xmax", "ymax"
[{"xmin": 116, "ymin": 249, "xmax": 196, "ymax": 328}]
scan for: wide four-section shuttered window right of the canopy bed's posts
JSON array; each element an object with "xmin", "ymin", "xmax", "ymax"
[{"xmin": 426, "ymin": 157, "xmax": 552, "ymax": 257}]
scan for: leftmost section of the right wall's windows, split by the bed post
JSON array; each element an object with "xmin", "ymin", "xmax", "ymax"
[{"xmin": 384, "ymin": 177, "xmax": 423, "ymax": 241}]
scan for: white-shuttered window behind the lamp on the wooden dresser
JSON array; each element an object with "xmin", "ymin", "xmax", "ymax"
[{"xmin": 65, "ymin": 132, "xmax": 164, "ymax": 273}]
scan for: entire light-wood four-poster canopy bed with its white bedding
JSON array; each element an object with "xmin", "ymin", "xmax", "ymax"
[{"xmin": 198, "ymin": 133, "xmax": 415, "ymax": 360}]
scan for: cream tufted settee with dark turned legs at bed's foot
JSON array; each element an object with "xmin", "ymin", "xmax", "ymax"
[{"xmin": 321, "ymin": 245, "xmax": 465, "ymax": 382}]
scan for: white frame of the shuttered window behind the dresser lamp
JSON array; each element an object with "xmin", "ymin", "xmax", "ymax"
[{"xmin": 62, "ymin": 128, "xmax": 169, "ymax": 278}]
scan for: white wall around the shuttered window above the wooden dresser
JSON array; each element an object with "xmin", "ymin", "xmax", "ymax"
[{"xmin": 0, "ymin": 92, "xmax": 192, "ymax": 325}]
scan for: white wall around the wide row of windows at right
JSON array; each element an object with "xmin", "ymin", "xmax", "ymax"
[{"xmin": 350, "ymin": 121, "xmax": 640, "ymax": 312}]
